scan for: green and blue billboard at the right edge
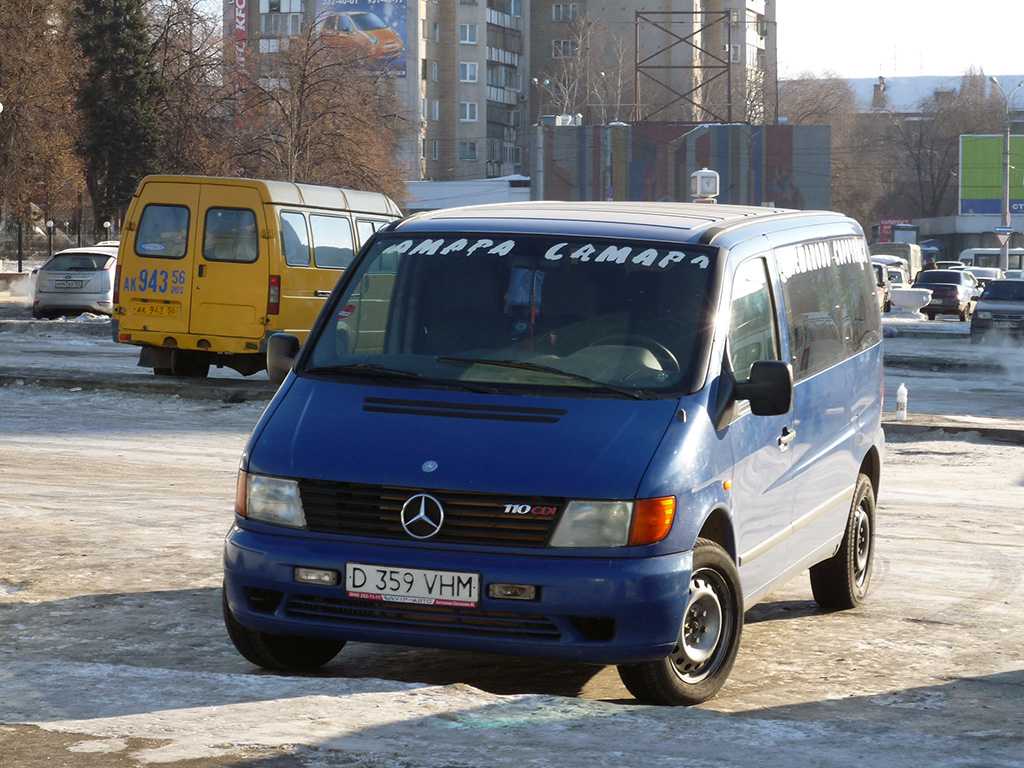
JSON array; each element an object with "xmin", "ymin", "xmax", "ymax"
[{"xmin": 959, "ymin": 135, "xmax": 1024, "ymax": 215}]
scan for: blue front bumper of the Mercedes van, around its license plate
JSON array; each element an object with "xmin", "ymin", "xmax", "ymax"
[{"xmin": 224, "ymin": 526, "xmax": 692, "ymax": 664}]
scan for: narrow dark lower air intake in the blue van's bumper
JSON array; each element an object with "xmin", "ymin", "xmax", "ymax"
[{"xmin": 285, "ymin": 595, "xmax": 561, "ymax": 641}]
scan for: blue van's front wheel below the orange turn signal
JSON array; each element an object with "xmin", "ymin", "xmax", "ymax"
[{"xmin": 618, "ymin": 539, "xmax": 743, "ymax": 706}]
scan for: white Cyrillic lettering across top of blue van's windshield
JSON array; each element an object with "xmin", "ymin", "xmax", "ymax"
[{"xmin": 381, "ymin": 238, "xmax": 711, "ymax": 269}]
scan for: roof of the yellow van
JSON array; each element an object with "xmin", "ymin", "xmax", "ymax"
[{"xmin": 135, "ymin": 175, "xmax": 401, "ymax": 216}]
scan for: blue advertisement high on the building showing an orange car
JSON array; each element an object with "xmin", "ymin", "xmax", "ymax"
[{"xmin": 315, "ymin": 0, "xmax": 408, "ymax": 77}]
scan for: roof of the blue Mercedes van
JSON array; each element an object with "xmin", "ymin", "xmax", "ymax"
[{"xmin": 393, "ymin": 201, "xmax": 861, "ymax": 246}]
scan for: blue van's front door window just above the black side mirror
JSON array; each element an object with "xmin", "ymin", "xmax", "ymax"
[{"xmin": 729, "ymin": 258, "xmax": 778, "ymax": 381}]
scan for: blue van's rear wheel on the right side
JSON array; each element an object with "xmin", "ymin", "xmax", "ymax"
[{"xmin": 811, "ymin": 475, "xmax": 874, "ymax": 610}]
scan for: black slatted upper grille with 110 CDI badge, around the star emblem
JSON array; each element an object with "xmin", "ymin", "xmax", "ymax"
[{"xmin": 299, "ymin": 480, "xmax": 565, "ymax": 548}]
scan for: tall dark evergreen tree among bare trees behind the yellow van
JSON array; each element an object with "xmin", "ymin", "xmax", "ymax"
[{"xmin": 77, "ymin": 0, "xmax": 160, "ymax": 228}]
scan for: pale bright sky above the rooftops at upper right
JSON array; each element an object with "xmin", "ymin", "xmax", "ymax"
[{"xmin": 775, "ymin": 0, "xmax": 1024, "ymax": 78}]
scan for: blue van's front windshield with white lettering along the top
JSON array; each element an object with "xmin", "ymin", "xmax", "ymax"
[{"xmin": 299, "ymin": 233, "xmax": 718, "ymax": 396}]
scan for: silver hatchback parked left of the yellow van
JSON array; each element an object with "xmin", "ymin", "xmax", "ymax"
[{"xmin": 32, "ymin": 241, "xmax": 118, "ymax": 317}]
